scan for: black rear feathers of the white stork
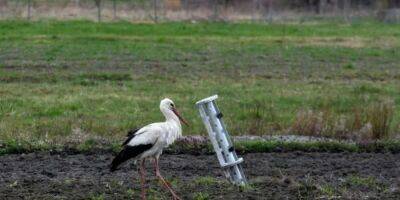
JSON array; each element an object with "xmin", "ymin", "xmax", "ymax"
[{"xmin": 110, "ymin": 144, "xmax": 153, "ymax": 172}]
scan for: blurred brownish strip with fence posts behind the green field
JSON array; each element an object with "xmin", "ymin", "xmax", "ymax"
[{"xmin": 0, "ymin": 0, "xmax": 400, "ymax": 22}]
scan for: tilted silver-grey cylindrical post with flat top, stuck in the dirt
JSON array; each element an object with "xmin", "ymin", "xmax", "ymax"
[{"xmin": 196, "ymin": 95, "xmax": 247, "ymax": 185}]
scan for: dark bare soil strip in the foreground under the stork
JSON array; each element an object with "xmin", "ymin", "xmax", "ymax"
[{"xmin": 0, "ymin": 152, "xmax": 400, "ymax": 199}]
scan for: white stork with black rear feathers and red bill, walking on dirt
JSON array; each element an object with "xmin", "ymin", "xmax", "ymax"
[{"xmin": 110, "ymin": 98, "xmax": 188, "ymax": 199}]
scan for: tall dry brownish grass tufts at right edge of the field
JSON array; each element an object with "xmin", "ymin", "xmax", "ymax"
[{"xmin": 290, "ymin": 100, "xmax": 394, "ymax": 140}]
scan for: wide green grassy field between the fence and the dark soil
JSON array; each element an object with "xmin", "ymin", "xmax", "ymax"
[{"xmin": 0, "ymin": 21, "xmax": 400, "ymax": 148}]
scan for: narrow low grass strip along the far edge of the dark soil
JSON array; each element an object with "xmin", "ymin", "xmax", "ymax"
[{"xmin": 0, "ymin": 139, "xmax": 400, "ymax": 156}]
